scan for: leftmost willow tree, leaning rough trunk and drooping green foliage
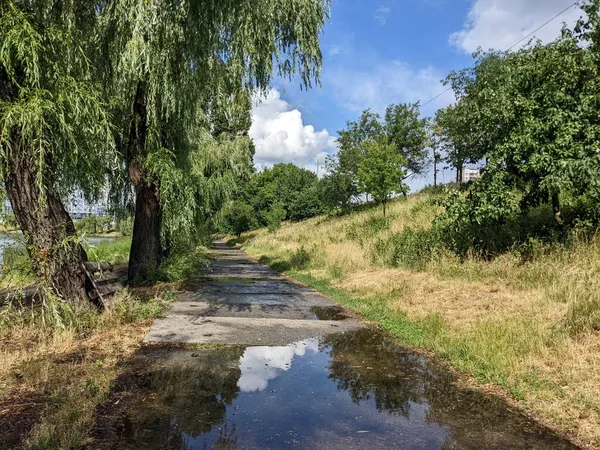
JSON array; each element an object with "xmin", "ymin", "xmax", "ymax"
[{"xmin": 0, "ymin": 0, "xmax": 115, "ymax": 301}]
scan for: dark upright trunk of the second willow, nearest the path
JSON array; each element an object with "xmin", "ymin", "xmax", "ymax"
[{"xmin": 127, "ymin": 82, "xmax": 162, "ymax": 284}]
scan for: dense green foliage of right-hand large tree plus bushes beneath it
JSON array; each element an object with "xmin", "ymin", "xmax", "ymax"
[{"xmin": 436, "ymin": 1, "xmax": 600, "ymax": 255}]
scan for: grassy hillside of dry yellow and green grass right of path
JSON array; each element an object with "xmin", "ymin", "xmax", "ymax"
[{"xmin": 234, "ymin": 193, "xmax": 600, "ymax": 446}]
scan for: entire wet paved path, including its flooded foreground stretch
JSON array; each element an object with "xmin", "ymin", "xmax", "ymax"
[{"xmin": 103, "ymin": 243, "xmax": 576, "ymax": 450}]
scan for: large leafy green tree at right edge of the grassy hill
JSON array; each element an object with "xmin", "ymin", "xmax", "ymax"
[{"xmin": 438, "ymin": 1, "xmax": 600, "ymax": 245}]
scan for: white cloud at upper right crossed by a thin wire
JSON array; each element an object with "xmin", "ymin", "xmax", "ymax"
[{"xmin": 450, "ymin": 0, "xmax": 582, "ymax": 53}]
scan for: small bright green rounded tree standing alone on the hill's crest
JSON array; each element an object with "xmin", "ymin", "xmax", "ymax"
[{"xmin": 358, "ymin": 141, "xmax": 408, "ymax": 216}]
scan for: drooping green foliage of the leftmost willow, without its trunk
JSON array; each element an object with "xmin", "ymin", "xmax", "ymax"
[{"xmin": 0, "ymin": 0, "xmax": 115, "ymax": 202}]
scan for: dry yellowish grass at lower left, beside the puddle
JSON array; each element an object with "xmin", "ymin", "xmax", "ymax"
[{"xmin": 0, "ymin": 293, "xmax": 171, "ymax": 448}]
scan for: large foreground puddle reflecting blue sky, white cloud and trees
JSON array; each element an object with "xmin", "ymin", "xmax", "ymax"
[{"xmin": 96, "ymin": 328, "xmax": 576, "ymax": 450}]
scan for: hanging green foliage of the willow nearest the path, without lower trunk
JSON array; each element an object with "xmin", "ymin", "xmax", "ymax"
[{"xmin": 101, "ymin": 0, "xmax": 329, "ymax": 268}]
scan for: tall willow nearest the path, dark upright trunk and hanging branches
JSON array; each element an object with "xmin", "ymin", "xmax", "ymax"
[{"xmin": 102, "ymin": 0, "xmax": 329, "ymax": 280}]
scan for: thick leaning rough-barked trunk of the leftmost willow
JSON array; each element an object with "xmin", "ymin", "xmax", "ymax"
[{"xmin": 4, "ymin": 133, "xmax": 91, "ymax": 302}]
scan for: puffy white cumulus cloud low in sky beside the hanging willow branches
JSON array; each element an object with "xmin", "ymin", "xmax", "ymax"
[{"xmin": 249, "ymin": 89, "xmax": 336, "ymax": 171}]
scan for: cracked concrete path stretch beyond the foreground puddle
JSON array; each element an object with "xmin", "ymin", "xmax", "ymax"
[{"xmin": 144, "ymin": 241, "xmax": 363, "ymax": 346}]
